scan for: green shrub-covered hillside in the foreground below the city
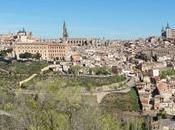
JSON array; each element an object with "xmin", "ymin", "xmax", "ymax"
[{"xmin": 0, "ymin": 62, "xmax": 146, "ymax": 130}]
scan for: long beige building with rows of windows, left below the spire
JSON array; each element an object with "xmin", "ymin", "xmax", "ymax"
[{"xmin": 14, "ymin": 43, "xmax": 67, "ymax": 61}]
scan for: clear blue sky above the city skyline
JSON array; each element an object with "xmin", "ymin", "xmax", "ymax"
[{"xmin": 0, "ymin": 0, "xmax": 175, "ymax": 39}]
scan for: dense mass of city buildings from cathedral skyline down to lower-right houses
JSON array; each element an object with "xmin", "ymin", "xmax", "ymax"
[{"xmin": 0, "ymin": 22, "xmax": 175, "ymax": 130}]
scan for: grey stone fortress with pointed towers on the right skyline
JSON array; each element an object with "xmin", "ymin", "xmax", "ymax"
[{"xmin": 161, "ymin": 24, "xmax": 175, "ymax": 39}]
